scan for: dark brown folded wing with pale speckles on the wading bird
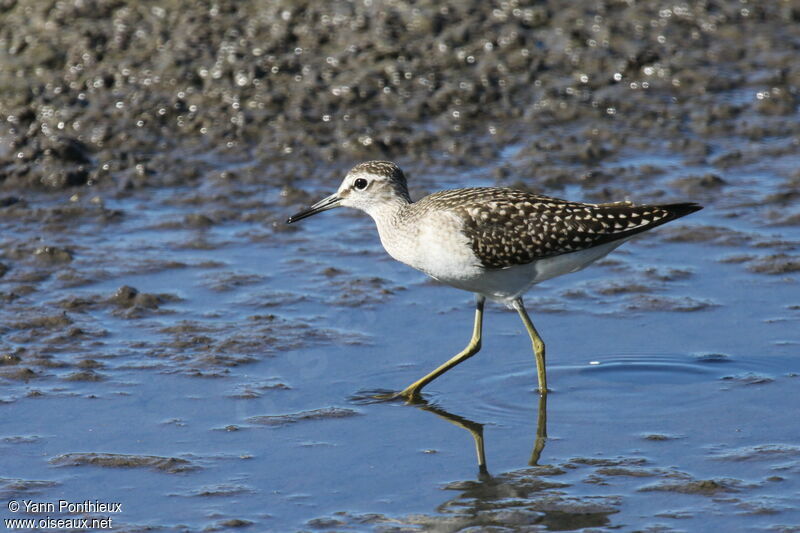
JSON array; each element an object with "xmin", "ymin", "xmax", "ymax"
[{"xmin": 418, "ymin": 187, "xmax": 702, "ymax": 269}]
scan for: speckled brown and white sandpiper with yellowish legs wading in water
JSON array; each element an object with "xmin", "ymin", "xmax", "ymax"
[{"xmin": 287, "ymin": 161, "xmax": 702, "ymax": 401}]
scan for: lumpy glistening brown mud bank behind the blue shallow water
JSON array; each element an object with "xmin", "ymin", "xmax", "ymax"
[{"xmin": 0, "ymin": 0, "xmax": 800, "ymax": 192}]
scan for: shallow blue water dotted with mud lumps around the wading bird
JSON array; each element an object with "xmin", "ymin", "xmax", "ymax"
[{"xmin": 0, "ymin": 137, "xmax": 800, "ymax": 531}]
